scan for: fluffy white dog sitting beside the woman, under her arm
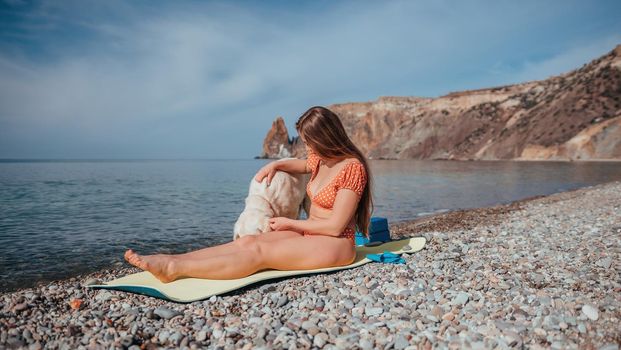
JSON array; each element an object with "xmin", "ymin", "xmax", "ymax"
[{"xmin": 233, "ymin": 158, "xmax": 310, "ymax": 240}]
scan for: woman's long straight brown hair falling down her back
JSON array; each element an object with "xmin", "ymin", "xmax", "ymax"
[{"xmin": 295, "ymin": 106, "xmax": 373, "ymax": 238}]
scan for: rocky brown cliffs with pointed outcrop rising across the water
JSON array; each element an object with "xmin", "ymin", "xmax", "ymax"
[{"xmin": 262, "ymin": 45, "xmax": 621, "ymax": 160}]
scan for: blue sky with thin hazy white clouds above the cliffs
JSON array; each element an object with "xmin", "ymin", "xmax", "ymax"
[{"xmin": 0, "ymin": 0, "xmax": 621, "ymax": 159}]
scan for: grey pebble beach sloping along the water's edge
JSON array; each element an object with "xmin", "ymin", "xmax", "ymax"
[{"xmin": 0, "ymin": 181, "xmax": 621, "ymax": 350}]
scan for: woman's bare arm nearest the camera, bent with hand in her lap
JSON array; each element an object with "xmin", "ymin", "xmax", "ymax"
[{"xmin": 270, "ymin": 188, "xmax": 360, "ymax": 237}]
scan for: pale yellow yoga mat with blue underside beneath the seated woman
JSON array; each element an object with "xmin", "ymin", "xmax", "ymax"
[{"xmin": 87, "ymin": 237, "xmax": 426, "ymax": 303}]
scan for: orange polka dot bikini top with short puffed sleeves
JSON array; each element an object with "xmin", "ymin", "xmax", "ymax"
[{"xmin": 306, "ymin": 151, "xmax": 367, "ymax": 209}]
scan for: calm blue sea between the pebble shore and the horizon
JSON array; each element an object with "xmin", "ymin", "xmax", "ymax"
[{"xmin": 0, "ymin": 159, "xmax": 621, "ymax": 292}]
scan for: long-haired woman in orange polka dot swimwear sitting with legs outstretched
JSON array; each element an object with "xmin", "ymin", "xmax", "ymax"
[{"xmin": 125, "ymin": 106, "xmax": 373, "ymax": 283}]
